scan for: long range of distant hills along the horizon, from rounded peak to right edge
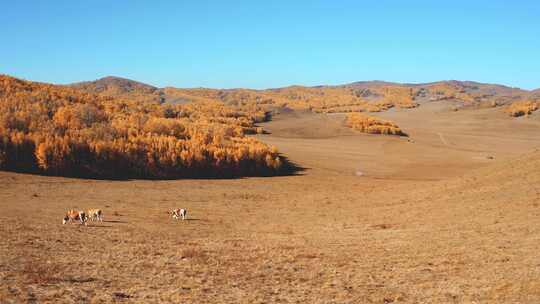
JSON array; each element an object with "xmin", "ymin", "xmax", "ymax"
[{"xmin": 64, "ymin": 76, "xmax": 540, "ymax": 113}]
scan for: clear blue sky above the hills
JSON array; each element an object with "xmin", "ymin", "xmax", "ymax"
[{"xmin": 0, "ymin": 0, "xmax": 540, "ymax": 89}]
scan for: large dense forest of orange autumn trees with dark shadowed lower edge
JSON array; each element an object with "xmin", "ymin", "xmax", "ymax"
[{"xmin": 0, "ymin": 76, "xmax": 283, "ymax": 178}]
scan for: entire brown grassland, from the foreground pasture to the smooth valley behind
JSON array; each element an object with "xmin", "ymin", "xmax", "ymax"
[{"xmin": 0, "ymin": 101, "xmax": 540, "ymax": 303}]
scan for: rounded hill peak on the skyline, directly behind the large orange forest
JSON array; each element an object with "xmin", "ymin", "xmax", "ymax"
[{"xmin": 70, "ymin": 76, "xmax": 158, "ymax": 96}]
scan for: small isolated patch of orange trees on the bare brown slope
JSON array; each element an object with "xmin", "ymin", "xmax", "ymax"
[{"xmin": 345, "ymin": 113, "xmax": 407, "ymax": 136}]
